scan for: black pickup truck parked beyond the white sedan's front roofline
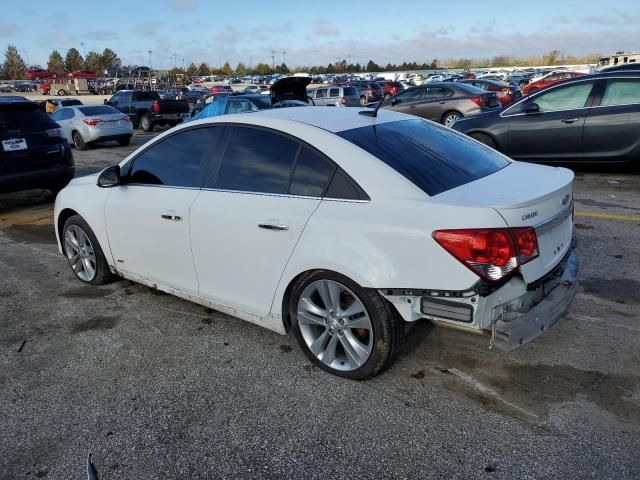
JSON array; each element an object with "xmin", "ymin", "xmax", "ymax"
[{"xmin": 104, "ymin": 90, "xmax": 189, "ymax": 132}]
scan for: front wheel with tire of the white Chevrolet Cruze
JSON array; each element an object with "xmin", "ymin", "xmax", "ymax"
[{"xmin": 62, "ymin": 215, "xmax": 114, "ymax": 285}]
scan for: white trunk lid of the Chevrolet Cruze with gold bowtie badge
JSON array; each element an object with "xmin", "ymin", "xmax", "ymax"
[{"xmin": 433, "ymin": 162, "xmax": 573, "ymax": 283}]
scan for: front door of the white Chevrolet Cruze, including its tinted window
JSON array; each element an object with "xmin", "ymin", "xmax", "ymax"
[{"xmin": 105, "ymin": 127, "xmax": 222, "ymax": 294}]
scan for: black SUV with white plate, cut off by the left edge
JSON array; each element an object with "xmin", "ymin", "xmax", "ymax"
[{"xmin": 0, "ymin": 97, "xmax": 75, "ymax": 194}]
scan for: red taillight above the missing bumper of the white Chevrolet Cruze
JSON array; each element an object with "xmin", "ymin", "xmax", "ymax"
[{"xmin": 433, "ymin": 227, "xmax": 538, "ymax": 282}]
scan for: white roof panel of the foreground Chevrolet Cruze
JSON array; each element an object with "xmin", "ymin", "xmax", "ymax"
[{"xmin": 213, "ymin": 106, "xmax": 415, "ymax": 133}]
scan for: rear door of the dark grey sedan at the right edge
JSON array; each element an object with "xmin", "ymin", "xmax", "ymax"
[{"xmin": 584, "ymin": 78, "xmax": 640, "ymax": 161}]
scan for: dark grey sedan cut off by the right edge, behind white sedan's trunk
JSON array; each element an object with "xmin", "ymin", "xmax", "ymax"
[{"xmin": 453, "ymin": 72, "xmax": 640, "ymax": 165}]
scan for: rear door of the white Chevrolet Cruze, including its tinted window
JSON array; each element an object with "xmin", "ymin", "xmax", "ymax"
[{"xmin": 191, "ymin": 125, "xmax": 335, "ymax": 318}]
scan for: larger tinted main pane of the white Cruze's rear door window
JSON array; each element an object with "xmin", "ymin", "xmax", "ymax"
[{"xmin": 216, "ymin": 127, "xmax": 299, "ymax": 193}]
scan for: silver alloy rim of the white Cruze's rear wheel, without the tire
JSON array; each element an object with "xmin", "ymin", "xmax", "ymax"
[{"xmin": 298, "ymin": 279, "xmax": 374, "ymax": 371}]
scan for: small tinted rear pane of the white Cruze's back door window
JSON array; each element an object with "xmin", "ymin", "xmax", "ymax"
[{"xmin": 289, "ymin": 148, "xmax": 336, "ymax": 197}]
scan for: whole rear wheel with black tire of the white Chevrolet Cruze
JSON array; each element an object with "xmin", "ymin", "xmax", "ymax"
[{"xmin": 290, "ymin": 270, "xmax": 404, "ymax": 380}]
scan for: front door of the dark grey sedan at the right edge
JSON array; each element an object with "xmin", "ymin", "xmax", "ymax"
[{"xmin": 503, "ymin": 80, "xmax": 595, "ymax": 161}]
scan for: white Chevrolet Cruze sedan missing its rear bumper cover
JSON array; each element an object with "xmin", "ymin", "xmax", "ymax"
[{"xmin": 55, "ymin": 107, "xmax": 578, "ymax": 379}]
